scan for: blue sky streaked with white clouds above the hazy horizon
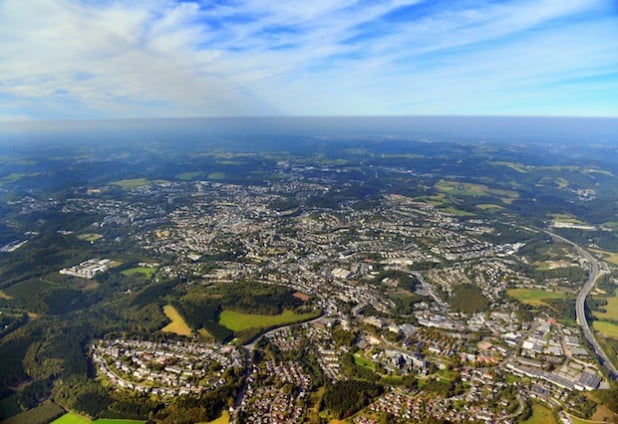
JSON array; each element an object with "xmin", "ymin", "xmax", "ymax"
[{"xmin": 0, "ymin": 0, "xmax": 618, "ymax": 121}]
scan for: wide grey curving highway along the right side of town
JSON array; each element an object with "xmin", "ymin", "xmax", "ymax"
[{"xmin": 545, "ymin": 230, "xmax": 618, "ymax": 381}]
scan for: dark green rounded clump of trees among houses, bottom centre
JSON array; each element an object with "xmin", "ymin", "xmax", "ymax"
[{"xmin": 324, "ymin": 380, "xmax": 384, "ymax": 420}]
